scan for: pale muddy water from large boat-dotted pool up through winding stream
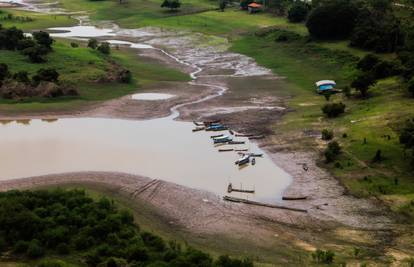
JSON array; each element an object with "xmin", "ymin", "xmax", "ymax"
[{"xmin": 0, "ymin": 1, "xmax": 291, "ymax": 202}]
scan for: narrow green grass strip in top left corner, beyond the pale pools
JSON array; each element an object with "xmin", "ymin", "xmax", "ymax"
[{"xmin": 0, "ymin": 9, "xmax": 77, "ymax": 31}]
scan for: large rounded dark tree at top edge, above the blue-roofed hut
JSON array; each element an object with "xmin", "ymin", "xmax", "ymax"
[{"xmin": 306, "ymin": 0, "xmax": 358, "ymax": 39}]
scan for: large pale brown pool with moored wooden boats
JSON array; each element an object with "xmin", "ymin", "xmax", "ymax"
[{"xmin": 0, "ymin": 117, "xmax": 291, "ymax": 202}]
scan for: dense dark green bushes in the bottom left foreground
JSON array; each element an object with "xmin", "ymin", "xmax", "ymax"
[{"xmin": 0, "ymin": 189, "xmax": 253, "ymax": 267}]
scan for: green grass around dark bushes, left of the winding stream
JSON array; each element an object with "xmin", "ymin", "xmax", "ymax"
[{"xmin": 0, "ymin": 40, "xmax": 189, "ymax": 113}]
